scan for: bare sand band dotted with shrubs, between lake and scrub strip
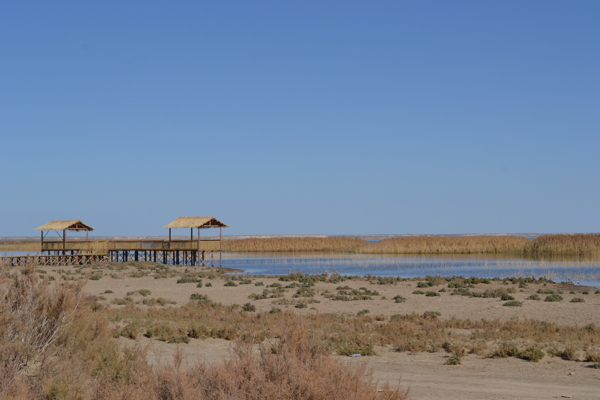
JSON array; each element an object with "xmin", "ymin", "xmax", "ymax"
[{"xmin": 81, "ymin": 270, "xmax": 600, "ymax": 326}]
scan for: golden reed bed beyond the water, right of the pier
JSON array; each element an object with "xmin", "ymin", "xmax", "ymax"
[{"xmin": 223, "ymin": 234, "xmax": 600, "ymax": 256}]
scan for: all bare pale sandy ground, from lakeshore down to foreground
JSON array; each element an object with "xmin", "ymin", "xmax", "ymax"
[{"xmin": 36, "ymin": 267, "xmax": 600, "ymax": 399}]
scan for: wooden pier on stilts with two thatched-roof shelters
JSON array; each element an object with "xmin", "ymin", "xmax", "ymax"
[{"xmin": 0, "ymin": 217, "xmax": 227, "ymax": 267}]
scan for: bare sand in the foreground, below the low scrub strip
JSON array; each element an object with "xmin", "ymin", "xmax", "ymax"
[{"xmin": 120, "ymin": 338, "xmax": 600, "ymax": 400}]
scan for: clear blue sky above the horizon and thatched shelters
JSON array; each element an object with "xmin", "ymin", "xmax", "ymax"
[{"xmin": 0, "ymin": 0, "xmax": 600, "ymax": 236}]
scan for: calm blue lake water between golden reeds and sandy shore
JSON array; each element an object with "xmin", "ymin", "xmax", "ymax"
[{"xmin": 223, "ymin": 253, "xmax": 600, "ymax": 288}]
